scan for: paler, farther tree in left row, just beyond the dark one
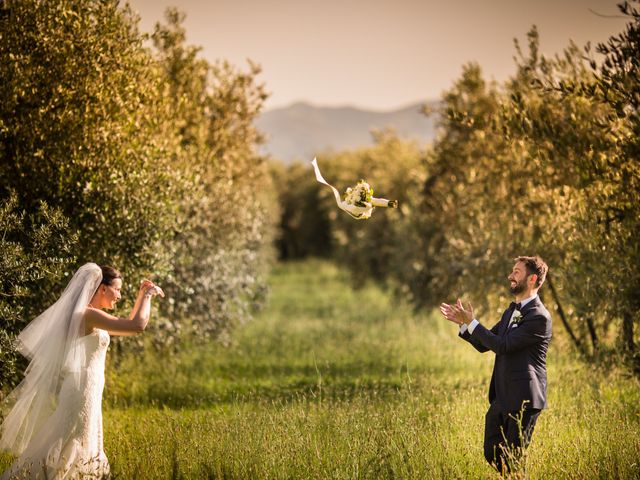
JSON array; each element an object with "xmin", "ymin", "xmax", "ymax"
[{"xmin": 153, "ymin": 10, "xmax": 277, "ymax": 340}]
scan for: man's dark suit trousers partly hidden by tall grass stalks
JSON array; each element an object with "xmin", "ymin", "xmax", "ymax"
[{"xmin": 484, "ymin": 400, "xmax": 540, "ymax": 472}]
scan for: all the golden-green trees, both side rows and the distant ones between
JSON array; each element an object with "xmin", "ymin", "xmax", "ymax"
[{"xmin": 0, "ymin": 0, "xmax": 640, "ymax": 386}]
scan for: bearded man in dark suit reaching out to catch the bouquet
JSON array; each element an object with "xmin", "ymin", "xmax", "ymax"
[{"xmin": 440, "ymin": 256, "xmax": 551, "ymax": 473}]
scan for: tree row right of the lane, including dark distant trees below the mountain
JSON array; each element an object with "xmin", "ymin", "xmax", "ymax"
[{"xmin": 275, "ymin": 0, "xmax": 640, "ymax": 372}]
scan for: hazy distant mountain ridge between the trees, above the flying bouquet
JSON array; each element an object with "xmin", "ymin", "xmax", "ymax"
[{"xmin": 256, "ymin": 102, "xmax": 435, "ymax": 163}]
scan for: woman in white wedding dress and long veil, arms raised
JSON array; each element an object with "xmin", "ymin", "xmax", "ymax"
[{"xmin": 0, "ymin": 263, "xmax": 164, "ymax": 480}]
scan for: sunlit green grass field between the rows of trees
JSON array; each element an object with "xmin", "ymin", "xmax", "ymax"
[{"xmin": 0, "ymin": 261, "xmax": 640, "ymax": 479}]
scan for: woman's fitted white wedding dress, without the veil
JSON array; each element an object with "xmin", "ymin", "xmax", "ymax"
[{"xmin": 2, "ymin": 329, "xmax": 110, "ymax": 480}]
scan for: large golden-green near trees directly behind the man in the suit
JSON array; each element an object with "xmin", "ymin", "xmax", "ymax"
[{"xmin": 404, "ymin": 4, "xmax": 640, "ymax": 368}]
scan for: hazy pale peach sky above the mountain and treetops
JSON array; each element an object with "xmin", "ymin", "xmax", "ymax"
[{"xmin": 129, "ymin": 0, "xmax": 626, "ymax": 110}]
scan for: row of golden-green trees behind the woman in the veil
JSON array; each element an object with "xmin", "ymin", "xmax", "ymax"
[{"xmin": 0, "ymin": 0, "xmax": 277, "ymax": 386}]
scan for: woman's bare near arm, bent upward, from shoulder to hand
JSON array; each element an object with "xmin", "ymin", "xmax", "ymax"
[{"xmin": 84, "ymin": 287, "xmax": 161, "ymax": 336}]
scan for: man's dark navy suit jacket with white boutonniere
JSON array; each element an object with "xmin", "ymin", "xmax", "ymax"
[{"xmin": 460, "ymin": 297, "xmax": 551, "ymax": 412}]
